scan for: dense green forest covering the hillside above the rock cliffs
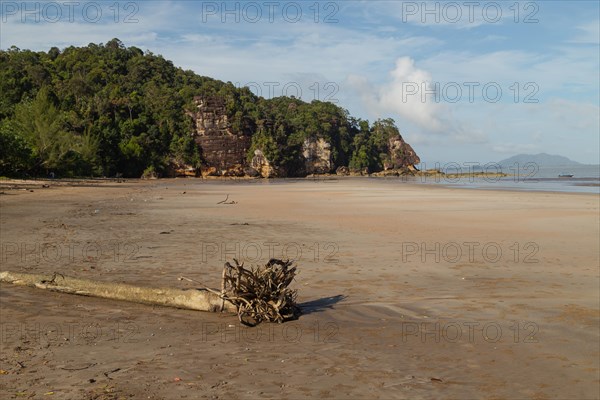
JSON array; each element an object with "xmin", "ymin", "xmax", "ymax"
[{"xmin": 0, "ymin": 39, "xmax": 420, "ymax": 177}]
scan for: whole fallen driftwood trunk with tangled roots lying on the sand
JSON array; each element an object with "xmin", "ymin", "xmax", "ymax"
[{"xmin": 0, "ymin": 259, "xmax": 300, "ymax": 326}]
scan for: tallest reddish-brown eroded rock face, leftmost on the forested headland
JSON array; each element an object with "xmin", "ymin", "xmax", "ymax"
[{"xmin": 188, "ymin": 97, "xmax": 251, "ymax": 176}]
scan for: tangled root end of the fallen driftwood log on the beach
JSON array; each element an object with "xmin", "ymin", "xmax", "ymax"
[{"xmin": 221, "ymin": 258, "xmax": 300, "ymax": 326}]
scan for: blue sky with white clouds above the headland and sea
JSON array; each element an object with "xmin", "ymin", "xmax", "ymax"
[{"xmin": 0, "ymin": 0, "xmax": 600, "ymax": 165}]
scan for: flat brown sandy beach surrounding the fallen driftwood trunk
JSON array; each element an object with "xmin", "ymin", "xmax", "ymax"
[{"xmin": 0, "ymin": 179, "xmax": 600, "ymax": 399}]
